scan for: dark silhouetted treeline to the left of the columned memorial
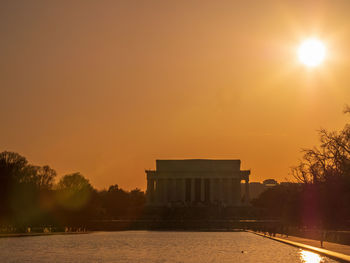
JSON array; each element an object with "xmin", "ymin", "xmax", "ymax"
[{"xmin": 0, "ymin": 151, "xmax": 145, "ymax": 231}]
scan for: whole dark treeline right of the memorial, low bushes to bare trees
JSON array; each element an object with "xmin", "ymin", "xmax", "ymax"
[{"xmin": 252, "ymin": 108, "xmax": 350, "ymax": 229}]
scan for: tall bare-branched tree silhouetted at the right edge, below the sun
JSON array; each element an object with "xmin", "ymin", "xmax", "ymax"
[{"xmin": 292, "ymin": 109, "xmax": 350, "ymax": 227}]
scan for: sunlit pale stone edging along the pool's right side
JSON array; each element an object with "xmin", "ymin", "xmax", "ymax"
[{"xmin": 246, "ymin": 231, "xmax": 350, "ymax": 262}]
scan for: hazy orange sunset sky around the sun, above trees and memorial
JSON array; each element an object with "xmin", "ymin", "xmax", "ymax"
[{"xmin": 0, "ymin": 0, "xmax": 350, "ymax": 189}]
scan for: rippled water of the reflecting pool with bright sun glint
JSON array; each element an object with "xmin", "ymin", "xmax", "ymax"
[{"xmin": 0, "ymin": 231, "xmax": 337, "ymax": 263}]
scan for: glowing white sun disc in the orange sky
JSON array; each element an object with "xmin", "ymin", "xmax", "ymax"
[{"xmin": 298, "ymin": 38, "xmax": 326, "ymax": 67}]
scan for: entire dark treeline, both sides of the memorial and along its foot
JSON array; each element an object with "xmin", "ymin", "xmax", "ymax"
[{"xmin": 0, "ymin": 108, "xmax": 350, "ymax": 231}]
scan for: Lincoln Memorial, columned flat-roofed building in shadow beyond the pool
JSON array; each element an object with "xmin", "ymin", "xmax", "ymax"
[{"xmin": 146, "ymin": 159, "xmax": 250, "ymax": 206}]
